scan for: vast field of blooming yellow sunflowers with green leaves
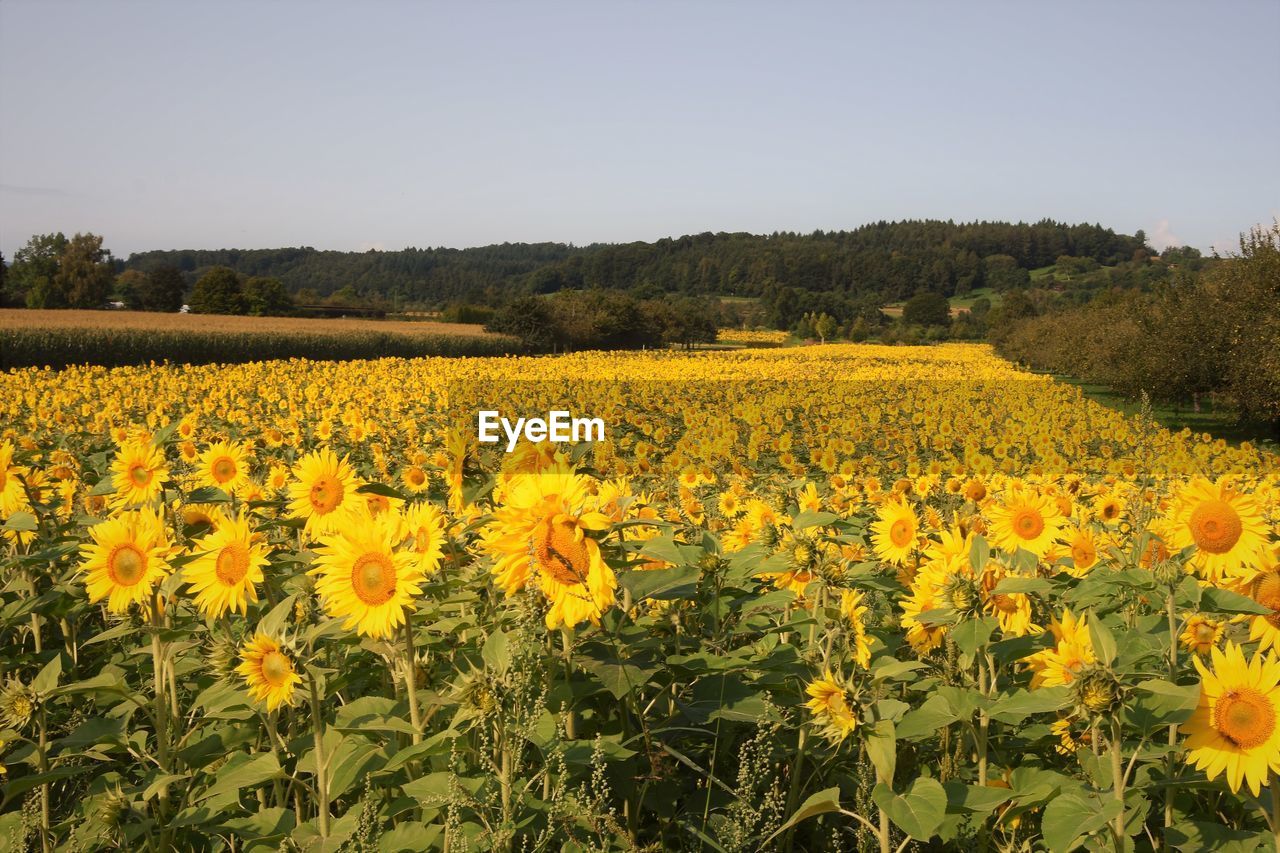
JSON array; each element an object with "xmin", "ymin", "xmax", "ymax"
[{"xmin": 0, "ymin": 345, "xmax": 1280, "ymax": 853}]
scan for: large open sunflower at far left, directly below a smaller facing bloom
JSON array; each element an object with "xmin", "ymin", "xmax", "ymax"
[{"xmin": 81, "ymin": 508, "xmax": 169, "ymax": 613}]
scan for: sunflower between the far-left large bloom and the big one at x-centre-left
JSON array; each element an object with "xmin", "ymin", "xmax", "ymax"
[{"xmin": 183, "ymin": 510, "xmax": 268, "ymax": 619}]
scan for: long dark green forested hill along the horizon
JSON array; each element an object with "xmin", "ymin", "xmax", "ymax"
[{"xmin": 125, "ymin": 219, "xmax": 1148, "ymax": 327}]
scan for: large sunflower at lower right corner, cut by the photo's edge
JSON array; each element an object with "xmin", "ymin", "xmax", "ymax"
[{"xmin": 1181, "ymin": 643, "xmax": 1280, "ymax": 797}]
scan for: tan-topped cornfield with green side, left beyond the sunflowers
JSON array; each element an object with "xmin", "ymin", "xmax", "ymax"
[{"xmin": 0, "ymin": 309, "xmax": 520, "ymax": 369}]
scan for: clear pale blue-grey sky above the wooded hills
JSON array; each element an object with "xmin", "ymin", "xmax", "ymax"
[{"xmin": 0, "ymin": 0, "xmax": 1280, "ymax": 259}]
